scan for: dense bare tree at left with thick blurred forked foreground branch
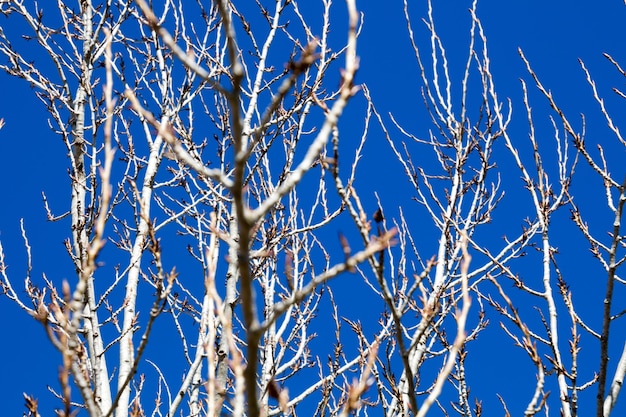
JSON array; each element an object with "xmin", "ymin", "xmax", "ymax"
[{"xmin": 1, "ymin": 1, "xmax": 392, "ymax": 416}]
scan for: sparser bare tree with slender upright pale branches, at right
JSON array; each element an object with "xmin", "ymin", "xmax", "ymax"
[{"xmin": 358, "ymin": 1, "xmax": 626, "ymax": 416}]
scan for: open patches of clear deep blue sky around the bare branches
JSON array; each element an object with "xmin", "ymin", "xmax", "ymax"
[{"xmin": 0, "ymin": 0, "xmax": 626, "ymax": 416}]
